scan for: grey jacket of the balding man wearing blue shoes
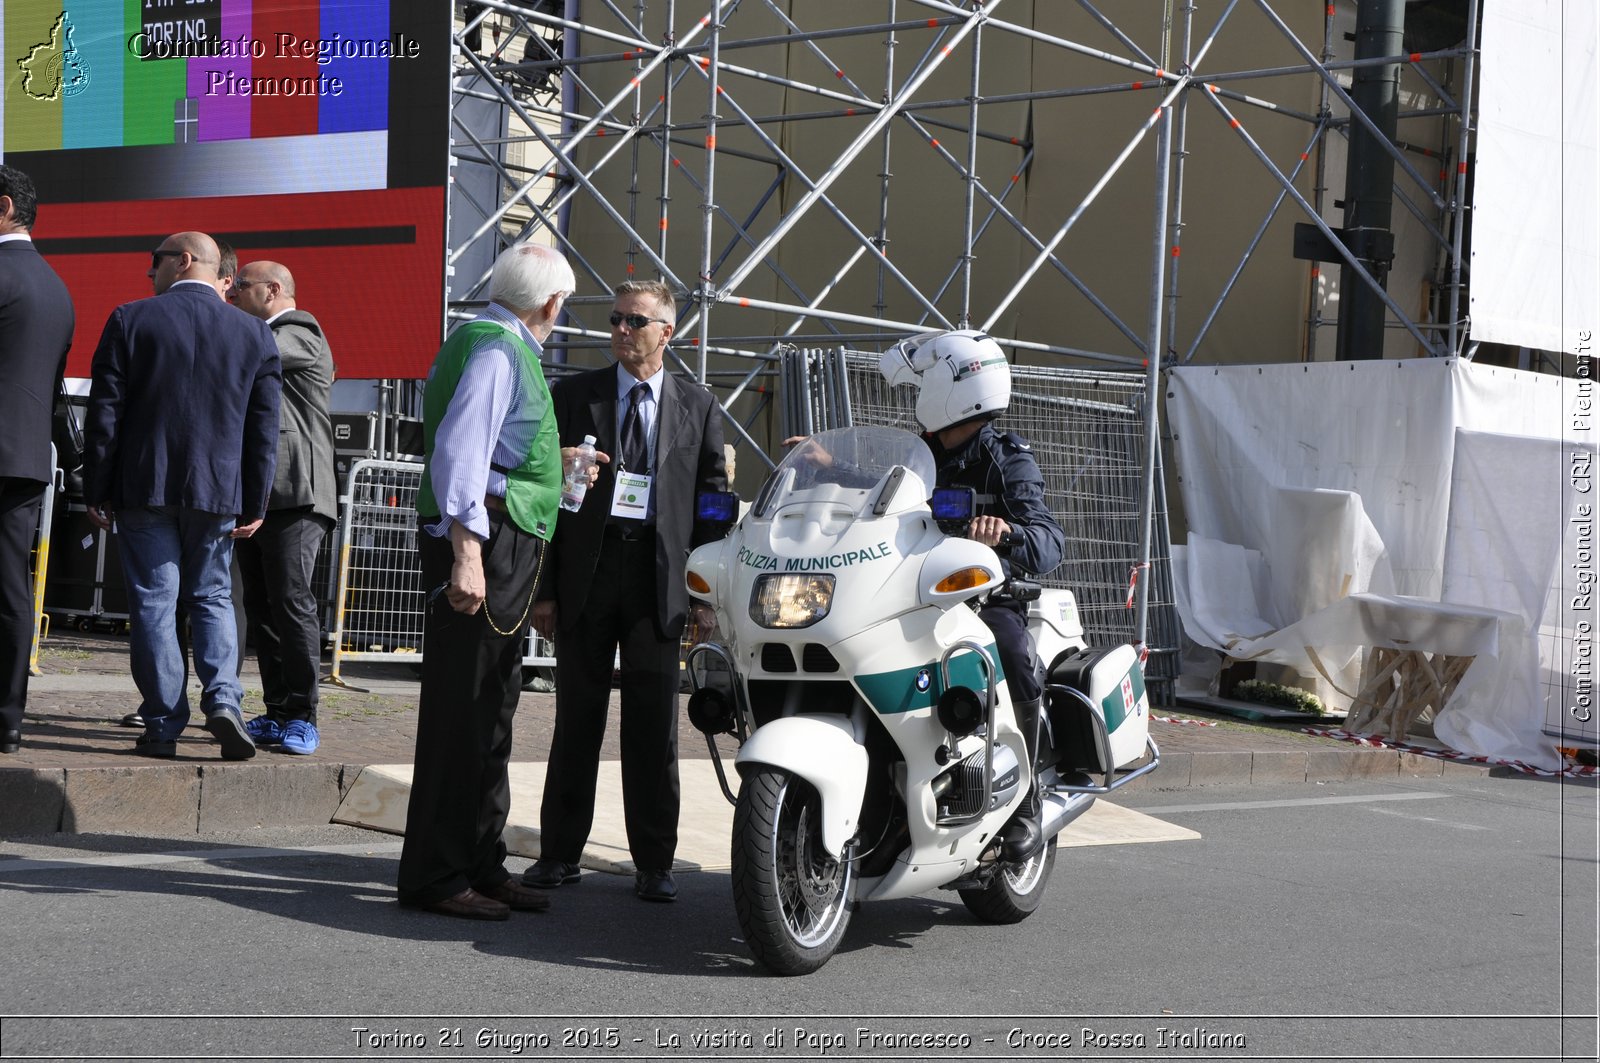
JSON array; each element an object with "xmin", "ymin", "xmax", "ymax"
[{"xmin": 267, "ymin": 309, "xmax": 339, "ymax": 520}]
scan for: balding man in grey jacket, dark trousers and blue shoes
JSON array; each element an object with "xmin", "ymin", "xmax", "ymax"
[{"xmin": 227, "ymin": 261, "xmax": 339, "ymax": 756}]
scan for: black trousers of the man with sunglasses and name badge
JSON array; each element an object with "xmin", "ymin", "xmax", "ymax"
[{"xmin": 539, "ymin": 530, "xmax": 678, "ymax": 871}]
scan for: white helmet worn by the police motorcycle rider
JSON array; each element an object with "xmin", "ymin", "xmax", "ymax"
[{"xmin": 878, "ymin": 328, "xmax": 1011, "ymax": 432}]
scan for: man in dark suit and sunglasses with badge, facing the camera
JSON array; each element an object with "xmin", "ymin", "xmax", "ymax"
[{"xmin": 523, "ymin": 280, "xmax": 728, "ymax": 901}]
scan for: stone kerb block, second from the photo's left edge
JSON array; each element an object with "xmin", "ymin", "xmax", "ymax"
[{"xmin": 61, "ymin": 762, "xmax": 200, "ymax": 834}]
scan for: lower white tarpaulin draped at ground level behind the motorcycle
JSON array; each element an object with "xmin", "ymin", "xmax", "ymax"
[{"xmin": 1168, "ymin": 359, "xmax": 1594, "ymax": 767}]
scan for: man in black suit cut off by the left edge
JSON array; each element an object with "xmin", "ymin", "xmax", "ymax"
[{"xmin": 0, "ymin": 166, "xmax": 72, "ymax": 752}]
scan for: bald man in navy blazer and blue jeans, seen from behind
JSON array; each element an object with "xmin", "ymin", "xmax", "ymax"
[{"xmin": 83, "ymin": 232, "xmax": 282, "ymax": 760}]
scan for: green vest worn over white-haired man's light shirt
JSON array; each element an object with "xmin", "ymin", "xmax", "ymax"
[{"xmin": 416, "ymin": 320, "xmax": 562, "ymax": 540}]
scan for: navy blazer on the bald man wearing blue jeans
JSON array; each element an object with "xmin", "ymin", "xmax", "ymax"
[{"xmin": 83, "ymin": 282, "xmax": 282, "ymax": 520}]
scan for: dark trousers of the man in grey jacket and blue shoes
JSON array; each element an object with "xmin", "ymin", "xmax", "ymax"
[{"xmin": 234, "ymin": 506, "xmax": 330, "ymax": 724}]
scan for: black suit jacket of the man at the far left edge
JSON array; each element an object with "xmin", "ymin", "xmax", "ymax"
[{"xmin": 0, "ymin": 240, "xmax": 74, "ymax": 483}]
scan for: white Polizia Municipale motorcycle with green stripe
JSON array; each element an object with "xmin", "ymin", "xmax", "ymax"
[{"xmin": 686, "ymin": 427, "xmax": 1160, "ymax": 975}]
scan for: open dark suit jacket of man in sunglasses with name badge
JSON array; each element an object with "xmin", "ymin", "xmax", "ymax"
[{"xmin": 539, "ymin": 363, "xmax": 728, "ymax": 639}]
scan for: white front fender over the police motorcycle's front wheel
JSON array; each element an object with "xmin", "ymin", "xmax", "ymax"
[{"xmin": 733, "ymin": 716, "xmax": 867, "ymax": 860}]
